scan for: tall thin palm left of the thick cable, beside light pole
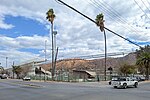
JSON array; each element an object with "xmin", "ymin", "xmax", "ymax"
[{"xmin": 46, "ymin": 9, "xmax": 56, "ymax": 80}]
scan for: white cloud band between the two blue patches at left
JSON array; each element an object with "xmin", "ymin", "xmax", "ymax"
[{"xmin": 0, "ymin": 35, "xmax": 51, "ymax": 49}]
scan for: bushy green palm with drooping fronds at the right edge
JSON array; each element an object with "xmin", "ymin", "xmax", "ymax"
[{"xmin": 136, "ymin": 52, "xmax": 150, "ymax": 80}]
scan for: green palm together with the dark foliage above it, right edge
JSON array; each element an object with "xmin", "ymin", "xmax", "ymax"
[{"xmin": 136, "ymin": 45, "xmax": 150, "ymax": 80}]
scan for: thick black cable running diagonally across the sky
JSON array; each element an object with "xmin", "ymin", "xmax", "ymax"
[{"xmin": 58, "ymin": 0, "xmax": 142, "ymax": 48}]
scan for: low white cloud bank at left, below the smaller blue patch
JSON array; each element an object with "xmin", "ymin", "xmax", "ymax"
[{"xmin": 0, "ymin": 49, "xmax": 43, "ymax": 68}]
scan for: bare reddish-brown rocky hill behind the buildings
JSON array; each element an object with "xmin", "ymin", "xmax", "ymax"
[{"xmin": 41, "ymin": 53, "xmax": 136, "ymax": 71}]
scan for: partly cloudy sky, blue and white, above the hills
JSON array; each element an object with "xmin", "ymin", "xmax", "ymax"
[{"xmin": 0, "ymin": 0, "xmax": 150, "ymax": 68}]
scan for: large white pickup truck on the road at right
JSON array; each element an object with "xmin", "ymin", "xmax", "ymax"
[{"xmin": 111, "ymin": 77, "xmax": 138, "ymax": 89}]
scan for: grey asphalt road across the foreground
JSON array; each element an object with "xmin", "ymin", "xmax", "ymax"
[{"xmin": 0, "ymin": 79, "xmax": 150, "ymax": 100}]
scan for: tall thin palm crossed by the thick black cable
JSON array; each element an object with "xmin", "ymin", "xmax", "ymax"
[{"xmin": 95, "ymin": 13, "xmax": 107, "ymax": 81}]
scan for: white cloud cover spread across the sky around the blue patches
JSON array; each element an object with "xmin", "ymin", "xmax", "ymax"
[{"xmin": 0, "ymin": 0, "xmax": 150, "ymax": 68}]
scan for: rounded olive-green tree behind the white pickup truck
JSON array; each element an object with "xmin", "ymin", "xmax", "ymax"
[{"xmin": 119, "ymin": 64, "xmax": 136, "ymax": 76}]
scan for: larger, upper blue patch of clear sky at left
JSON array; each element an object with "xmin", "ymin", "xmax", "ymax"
[{"xmin": 0, "ymin": 16, "xmax": 49, "ymax": 38}]
